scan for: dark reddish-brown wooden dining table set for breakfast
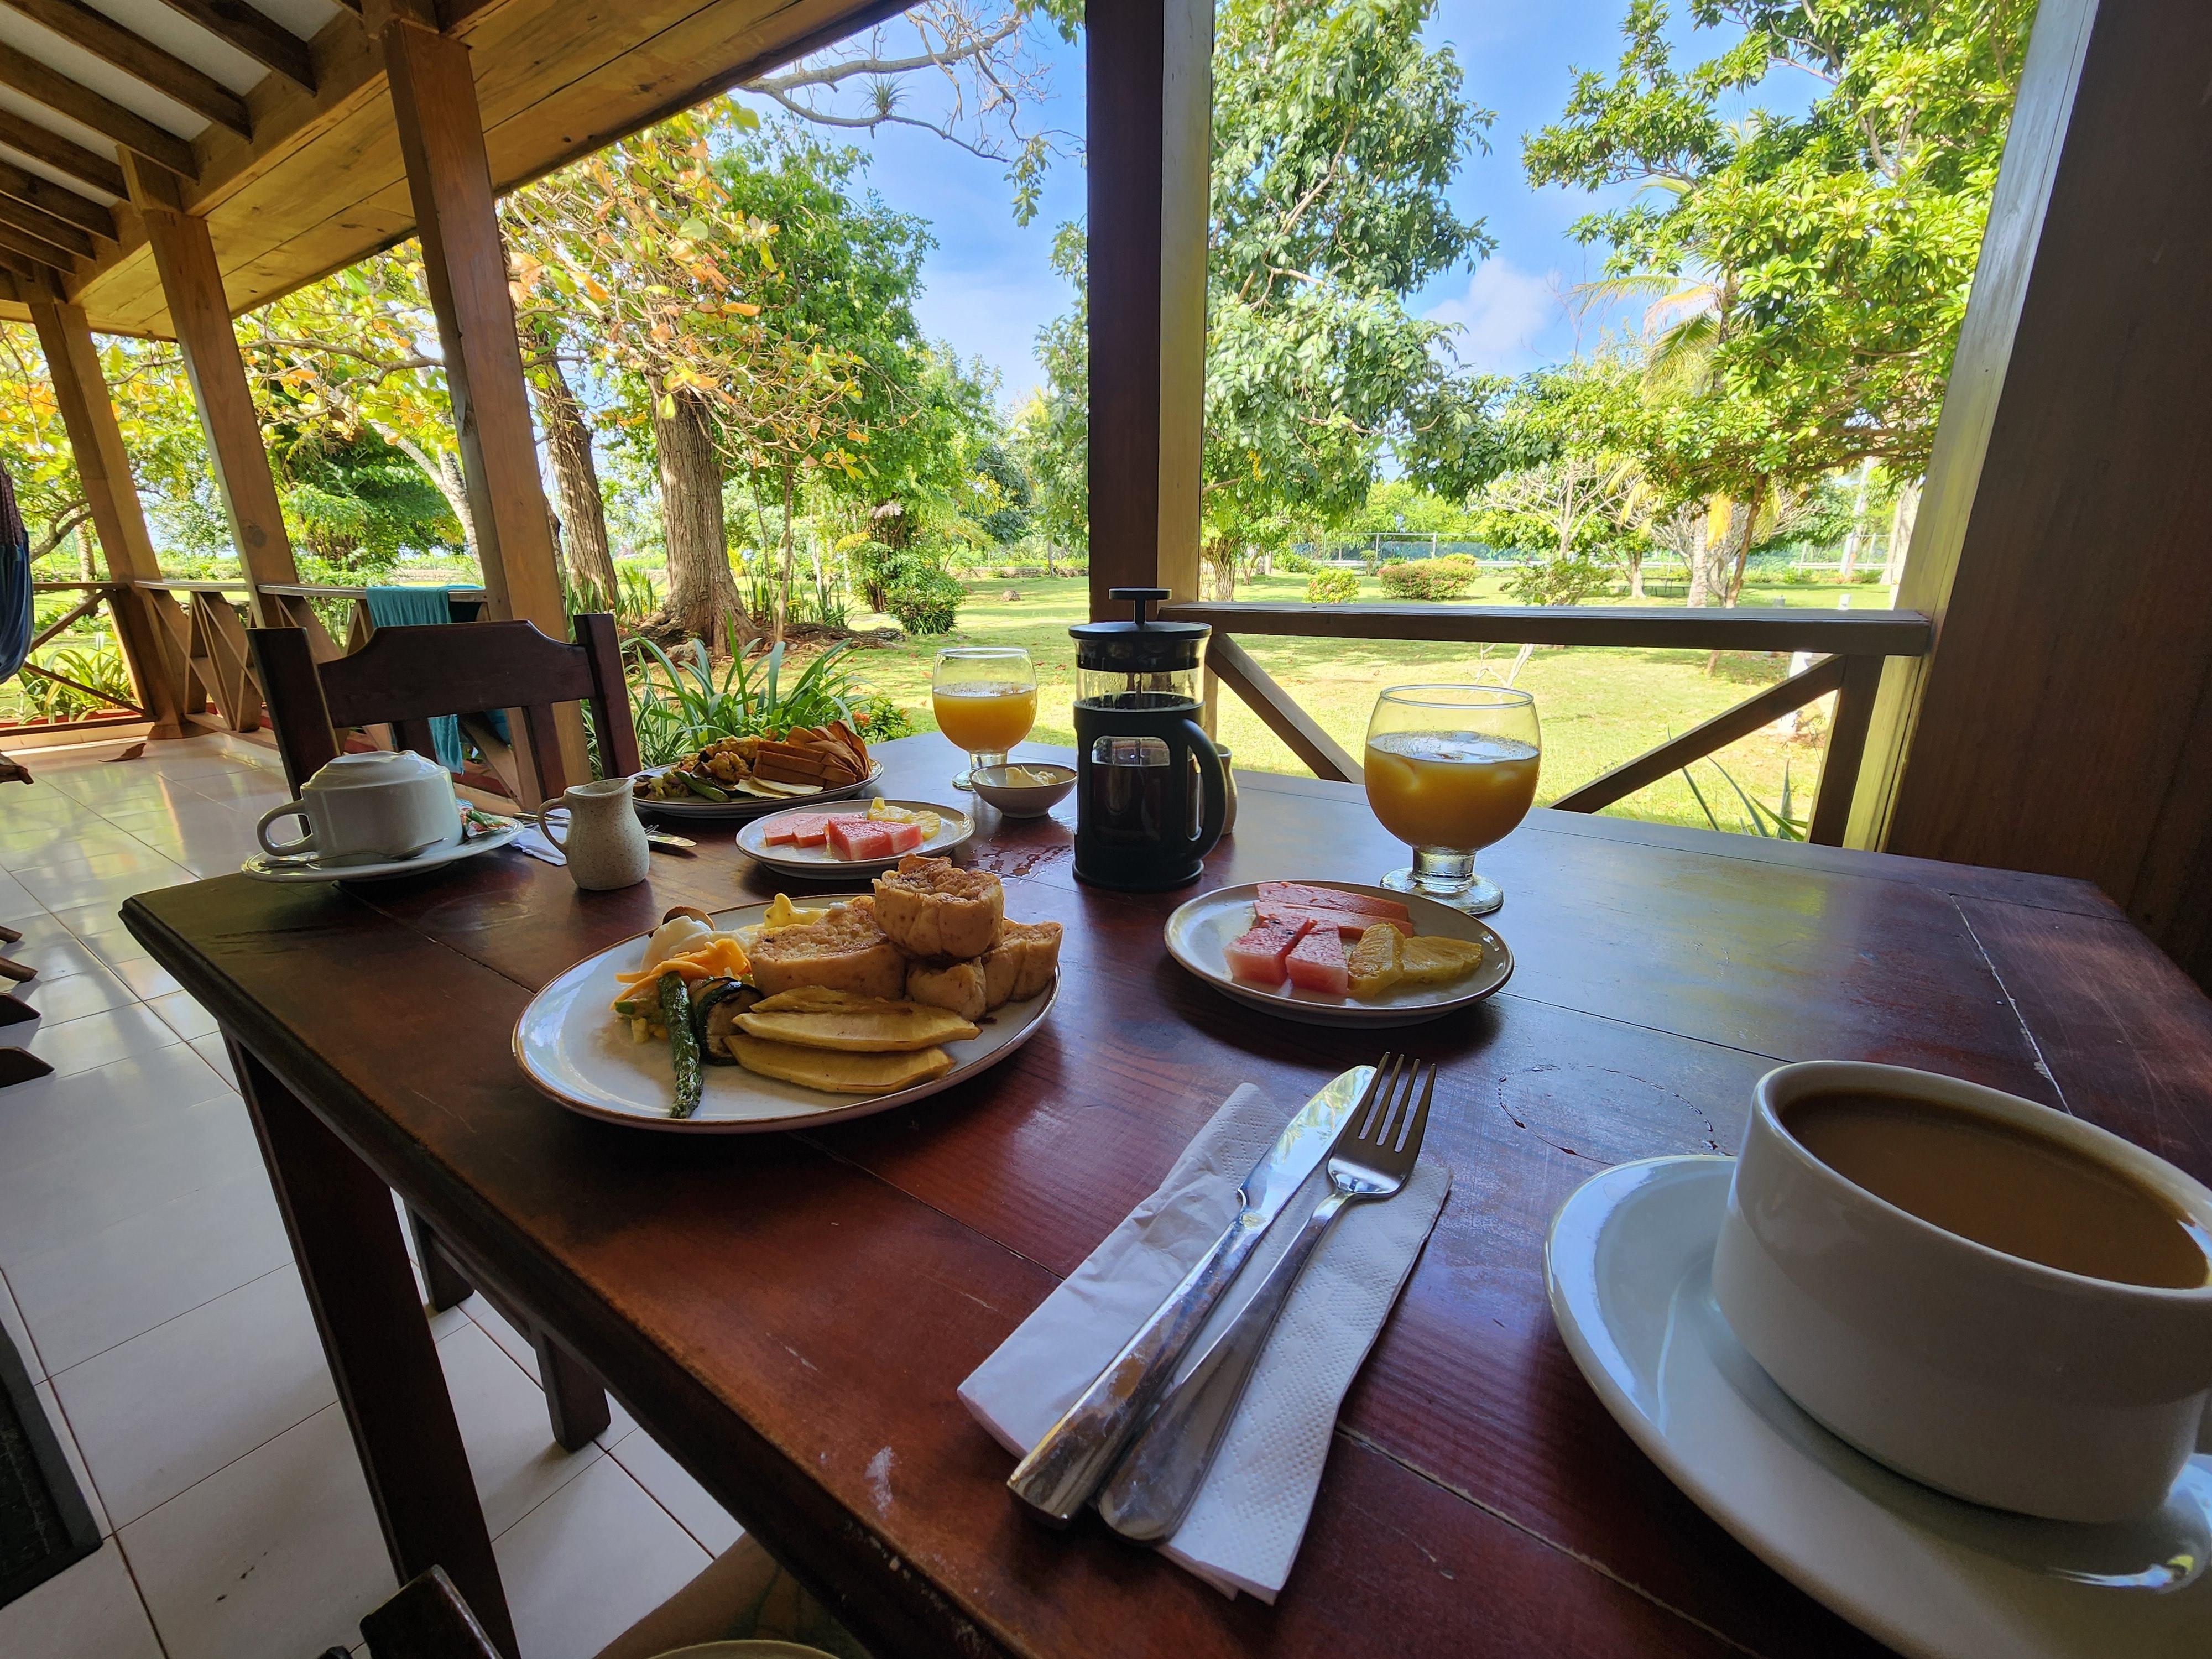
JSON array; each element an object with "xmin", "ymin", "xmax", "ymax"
[{"xmin": 124, "ymin": 734, "xmax": 2212, "ymax": 1659}]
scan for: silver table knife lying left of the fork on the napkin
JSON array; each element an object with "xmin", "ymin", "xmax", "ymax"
[{"xmin": 1006, "ymin": 1066, "xmax": 1374, "ymax": 1526}]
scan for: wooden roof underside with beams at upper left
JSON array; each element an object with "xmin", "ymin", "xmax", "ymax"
[{"xmin": 0, "ymin": 0, "xmax": 900, "ymax": 336}]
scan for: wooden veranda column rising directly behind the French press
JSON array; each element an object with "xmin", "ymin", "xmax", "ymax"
[{"xmin": 1084, "ymin": 0, "xmax": 1214, "ymax": 617}]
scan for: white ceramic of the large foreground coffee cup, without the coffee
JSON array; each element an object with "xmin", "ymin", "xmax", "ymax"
[{"xmin": 1712, "ymin": 1062, "xmax": 2212, "ymax": 1522}]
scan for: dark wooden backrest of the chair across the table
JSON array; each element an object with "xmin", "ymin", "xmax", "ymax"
[{"xmin": 246, "ymin": 613, "xmax": 637, "ymax": 799}]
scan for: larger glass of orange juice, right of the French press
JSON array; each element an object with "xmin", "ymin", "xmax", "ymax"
[{"xmin": 1365, "ymin": 686, "xmax": 1544, "ymax": 916}]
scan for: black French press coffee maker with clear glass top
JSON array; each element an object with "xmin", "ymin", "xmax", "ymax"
[{"xmin": 1068, "ymin": 588, "xmax": 1228, "ymax": 894}]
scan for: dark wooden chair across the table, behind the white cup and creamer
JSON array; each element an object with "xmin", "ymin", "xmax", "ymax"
[{"xmin": 246, "ymin": 613, "xmax": 637, "ymax": 1451}]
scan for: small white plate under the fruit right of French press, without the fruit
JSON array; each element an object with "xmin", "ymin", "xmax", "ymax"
[{"xmin": 1168, "ymin": 880, "xmax": 1513, "ymax": 1029}]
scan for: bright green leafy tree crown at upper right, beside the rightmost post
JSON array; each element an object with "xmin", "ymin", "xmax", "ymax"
[{"xmin": 1522, "ymin": 0, "xmax": 2035, "ymax": 520}]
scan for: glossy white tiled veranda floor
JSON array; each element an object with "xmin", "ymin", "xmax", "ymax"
[{"xmin": 0, "ymin": 737, "xmax": 737, "ymax": 1659}]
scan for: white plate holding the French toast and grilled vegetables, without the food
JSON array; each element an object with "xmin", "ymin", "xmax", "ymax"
[{"xmin": 515, "ymin": 894, "xmax": 1060, "ymax": 1135}]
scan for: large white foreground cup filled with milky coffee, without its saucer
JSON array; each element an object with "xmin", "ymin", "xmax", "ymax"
[{"xmin": 1712, "ymin": 1062, "xmax": 2212, "ymax": 1522}]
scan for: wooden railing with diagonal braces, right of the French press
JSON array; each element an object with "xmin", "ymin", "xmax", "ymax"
[{"xmin": 1159, "ymin": 604, "xmax": 1933, "ymax": 847}]
